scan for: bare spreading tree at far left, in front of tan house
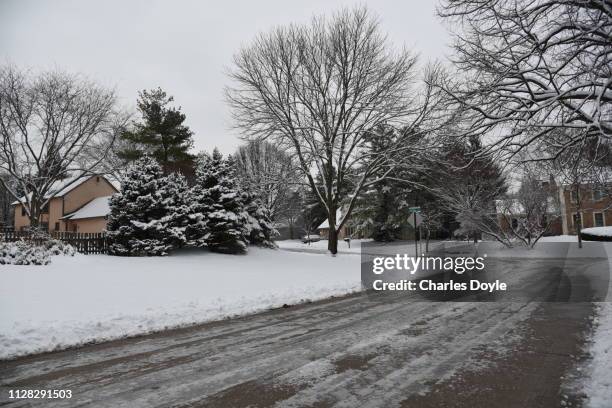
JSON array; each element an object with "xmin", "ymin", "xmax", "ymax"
[{"xmin": 0, "ymin": 65, "xmax": 122, "ymax": 227}]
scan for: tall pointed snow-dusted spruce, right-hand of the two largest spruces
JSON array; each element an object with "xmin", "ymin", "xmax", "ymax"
[{"xmin": 188, "ymin": 149, "xmax": 247, "ymax": 253}]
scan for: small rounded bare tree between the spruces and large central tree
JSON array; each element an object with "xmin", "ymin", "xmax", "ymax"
[{"xmin": 234, "ymin": 140, "xmax": 300, "ymax": 221}]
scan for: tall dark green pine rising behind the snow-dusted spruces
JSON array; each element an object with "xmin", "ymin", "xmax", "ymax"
[{"xmin": 118, "ymin": 88, "xmax": 193, "ymax": 172}]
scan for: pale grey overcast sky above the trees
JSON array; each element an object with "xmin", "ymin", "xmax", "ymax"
[{"xmin": 0, "ymin": 0, "xmax": 450, "ymax": 153}]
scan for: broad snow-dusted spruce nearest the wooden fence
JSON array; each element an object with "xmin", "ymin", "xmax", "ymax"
[{"xmin": 107, "ymin": 156, "xmax": 173, "ymax": 256}]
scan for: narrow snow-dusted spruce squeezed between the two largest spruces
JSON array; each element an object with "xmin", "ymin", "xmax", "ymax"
[{"xmin": 159, "ymin": 173, "xmax": 190, "ymax": 248}]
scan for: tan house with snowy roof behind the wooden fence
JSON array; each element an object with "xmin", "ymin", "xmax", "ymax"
[{"xmin": 12, "ymin": 175, "xmax": 118, "ymax": 233}]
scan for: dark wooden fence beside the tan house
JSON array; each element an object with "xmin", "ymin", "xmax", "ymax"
[{"xmin": 0, "ymin": 231, "xmax": 108, "ymax": 254}]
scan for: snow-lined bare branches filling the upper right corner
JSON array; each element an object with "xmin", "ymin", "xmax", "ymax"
[{"xmin": 439, "ymin": 0, "xmax": 612, "ymax": 158}]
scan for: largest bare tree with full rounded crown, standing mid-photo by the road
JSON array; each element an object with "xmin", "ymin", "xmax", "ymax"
[{"xmin": 227, "ymin": 8, "xmax": 442, "ymax": 253}]
